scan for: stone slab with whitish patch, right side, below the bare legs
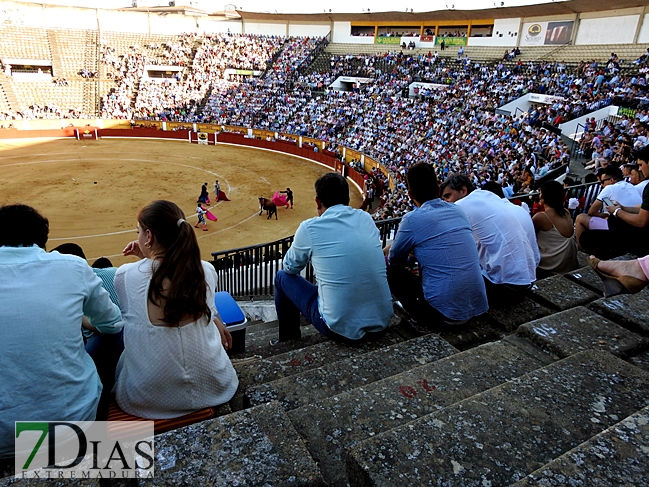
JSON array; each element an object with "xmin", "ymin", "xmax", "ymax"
[{"xmin": 517, "ymin": 306, "xmax": 649, "ymax": 358}]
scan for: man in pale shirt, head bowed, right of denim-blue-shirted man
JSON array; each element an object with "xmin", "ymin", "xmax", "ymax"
[{"xmin": 442, "ymin": 175, "xmax": 537, "ymax": 307}]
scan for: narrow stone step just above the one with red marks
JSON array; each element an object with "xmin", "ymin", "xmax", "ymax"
[{"xmin": 244, "ymin": 335, "xmax": 457, "ymax": 411}]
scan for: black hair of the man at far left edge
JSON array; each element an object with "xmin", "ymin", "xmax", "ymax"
[{"xmin": 0, "ymin": 205, "xmax": 50, "ymax": 249}]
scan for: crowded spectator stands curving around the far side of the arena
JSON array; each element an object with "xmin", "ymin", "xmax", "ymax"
[{"xmin": 0, "ymin": 27, "xmax": 649, "ymax": 218}]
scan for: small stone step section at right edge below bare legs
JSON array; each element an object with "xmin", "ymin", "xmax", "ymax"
[{"xmin": 588, "ymin": 288, "xmax": 649, "ymax": 336}]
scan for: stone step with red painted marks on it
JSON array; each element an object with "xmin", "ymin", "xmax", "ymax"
[{"xmin": 288, "ymin": 342, "xmax": 548, "ymax": 485}]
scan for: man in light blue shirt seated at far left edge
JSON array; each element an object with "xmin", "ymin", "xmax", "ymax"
[{"xmin": 0, "ymin": 205, "xmax": 121, "ymax": 458}]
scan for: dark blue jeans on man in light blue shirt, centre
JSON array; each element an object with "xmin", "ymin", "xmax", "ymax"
[{"xmin": 275, "ymin": 271, "xmax": 335, "ymax": 342}]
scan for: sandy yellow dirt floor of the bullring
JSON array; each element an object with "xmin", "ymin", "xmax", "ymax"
[{"xmin": 0, "ymin": 139, "xmax": 361, "ymax": 265}]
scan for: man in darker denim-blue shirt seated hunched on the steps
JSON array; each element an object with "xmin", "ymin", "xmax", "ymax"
[{"xmin": 384, "ymin": 163, "xmax": 488, "ymax": 325}]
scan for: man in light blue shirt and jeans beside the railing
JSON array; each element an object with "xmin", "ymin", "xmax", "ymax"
[{"xmin": 275, "ymin": 173, "xmax": 392, "ymax": 341}]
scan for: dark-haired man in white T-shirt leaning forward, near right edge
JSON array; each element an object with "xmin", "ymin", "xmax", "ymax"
[{"xmin": 575, "ymin": 165, "xmax": 642, "ymax": 249}]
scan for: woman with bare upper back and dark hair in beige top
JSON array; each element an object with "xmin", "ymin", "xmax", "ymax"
[{"xmin": 532, "ymin": 181, "xmax": 578, "ymax": 274}]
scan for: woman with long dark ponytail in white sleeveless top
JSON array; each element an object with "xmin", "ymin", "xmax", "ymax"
[{"xmin": 114, "ymin": 200, "xmax": 238, "ymax": 419}]
